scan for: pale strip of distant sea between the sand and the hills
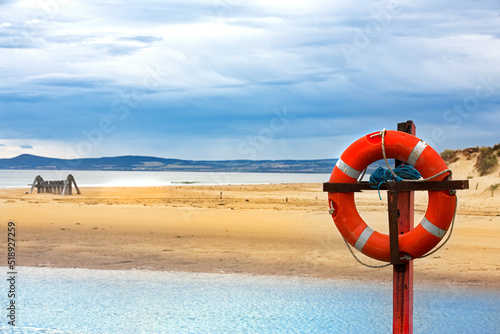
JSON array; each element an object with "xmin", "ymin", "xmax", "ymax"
[{"xmin": 0, "ymin": 170, "xmax": 336, "ymax": 188}]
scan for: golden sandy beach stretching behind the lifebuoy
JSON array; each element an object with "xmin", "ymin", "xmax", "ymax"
[{"xmin": 0, "ymin": 156, "xmax": 500, "ymax": 289}]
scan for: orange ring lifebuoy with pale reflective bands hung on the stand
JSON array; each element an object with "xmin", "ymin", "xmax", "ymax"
[{"xmin": 328, "ymin": 131, "xmax": 456, "ymax": 262}]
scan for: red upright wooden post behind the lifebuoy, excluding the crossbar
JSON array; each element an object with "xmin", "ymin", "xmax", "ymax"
[{"xmin": 389, "ymin": 121, "xmax": 416, "ymax": 334}]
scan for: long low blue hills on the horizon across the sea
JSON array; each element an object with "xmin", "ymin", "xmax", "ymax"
[{"xmin": 0, "ymin": 154, "xmax": 344, "ymax": 173}]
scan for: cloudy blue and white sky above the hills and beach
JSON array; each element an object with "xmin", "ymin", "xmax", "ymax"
[{"xmin": 0, "ymin": 0, "xmax": 500, "ymax": 160}]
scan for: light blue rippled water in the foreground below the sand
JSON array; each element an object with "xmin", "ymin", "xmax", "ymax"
[{"xmin": 0, "ymin": 267, "xmax": 500, "ymax": 334}]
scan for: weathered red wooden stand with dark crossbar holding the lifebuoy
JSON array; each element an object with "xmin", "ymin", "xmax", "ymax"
[{"xmin": 323, "ymin": 121, "xmax": 469, "ymax": 334}]
